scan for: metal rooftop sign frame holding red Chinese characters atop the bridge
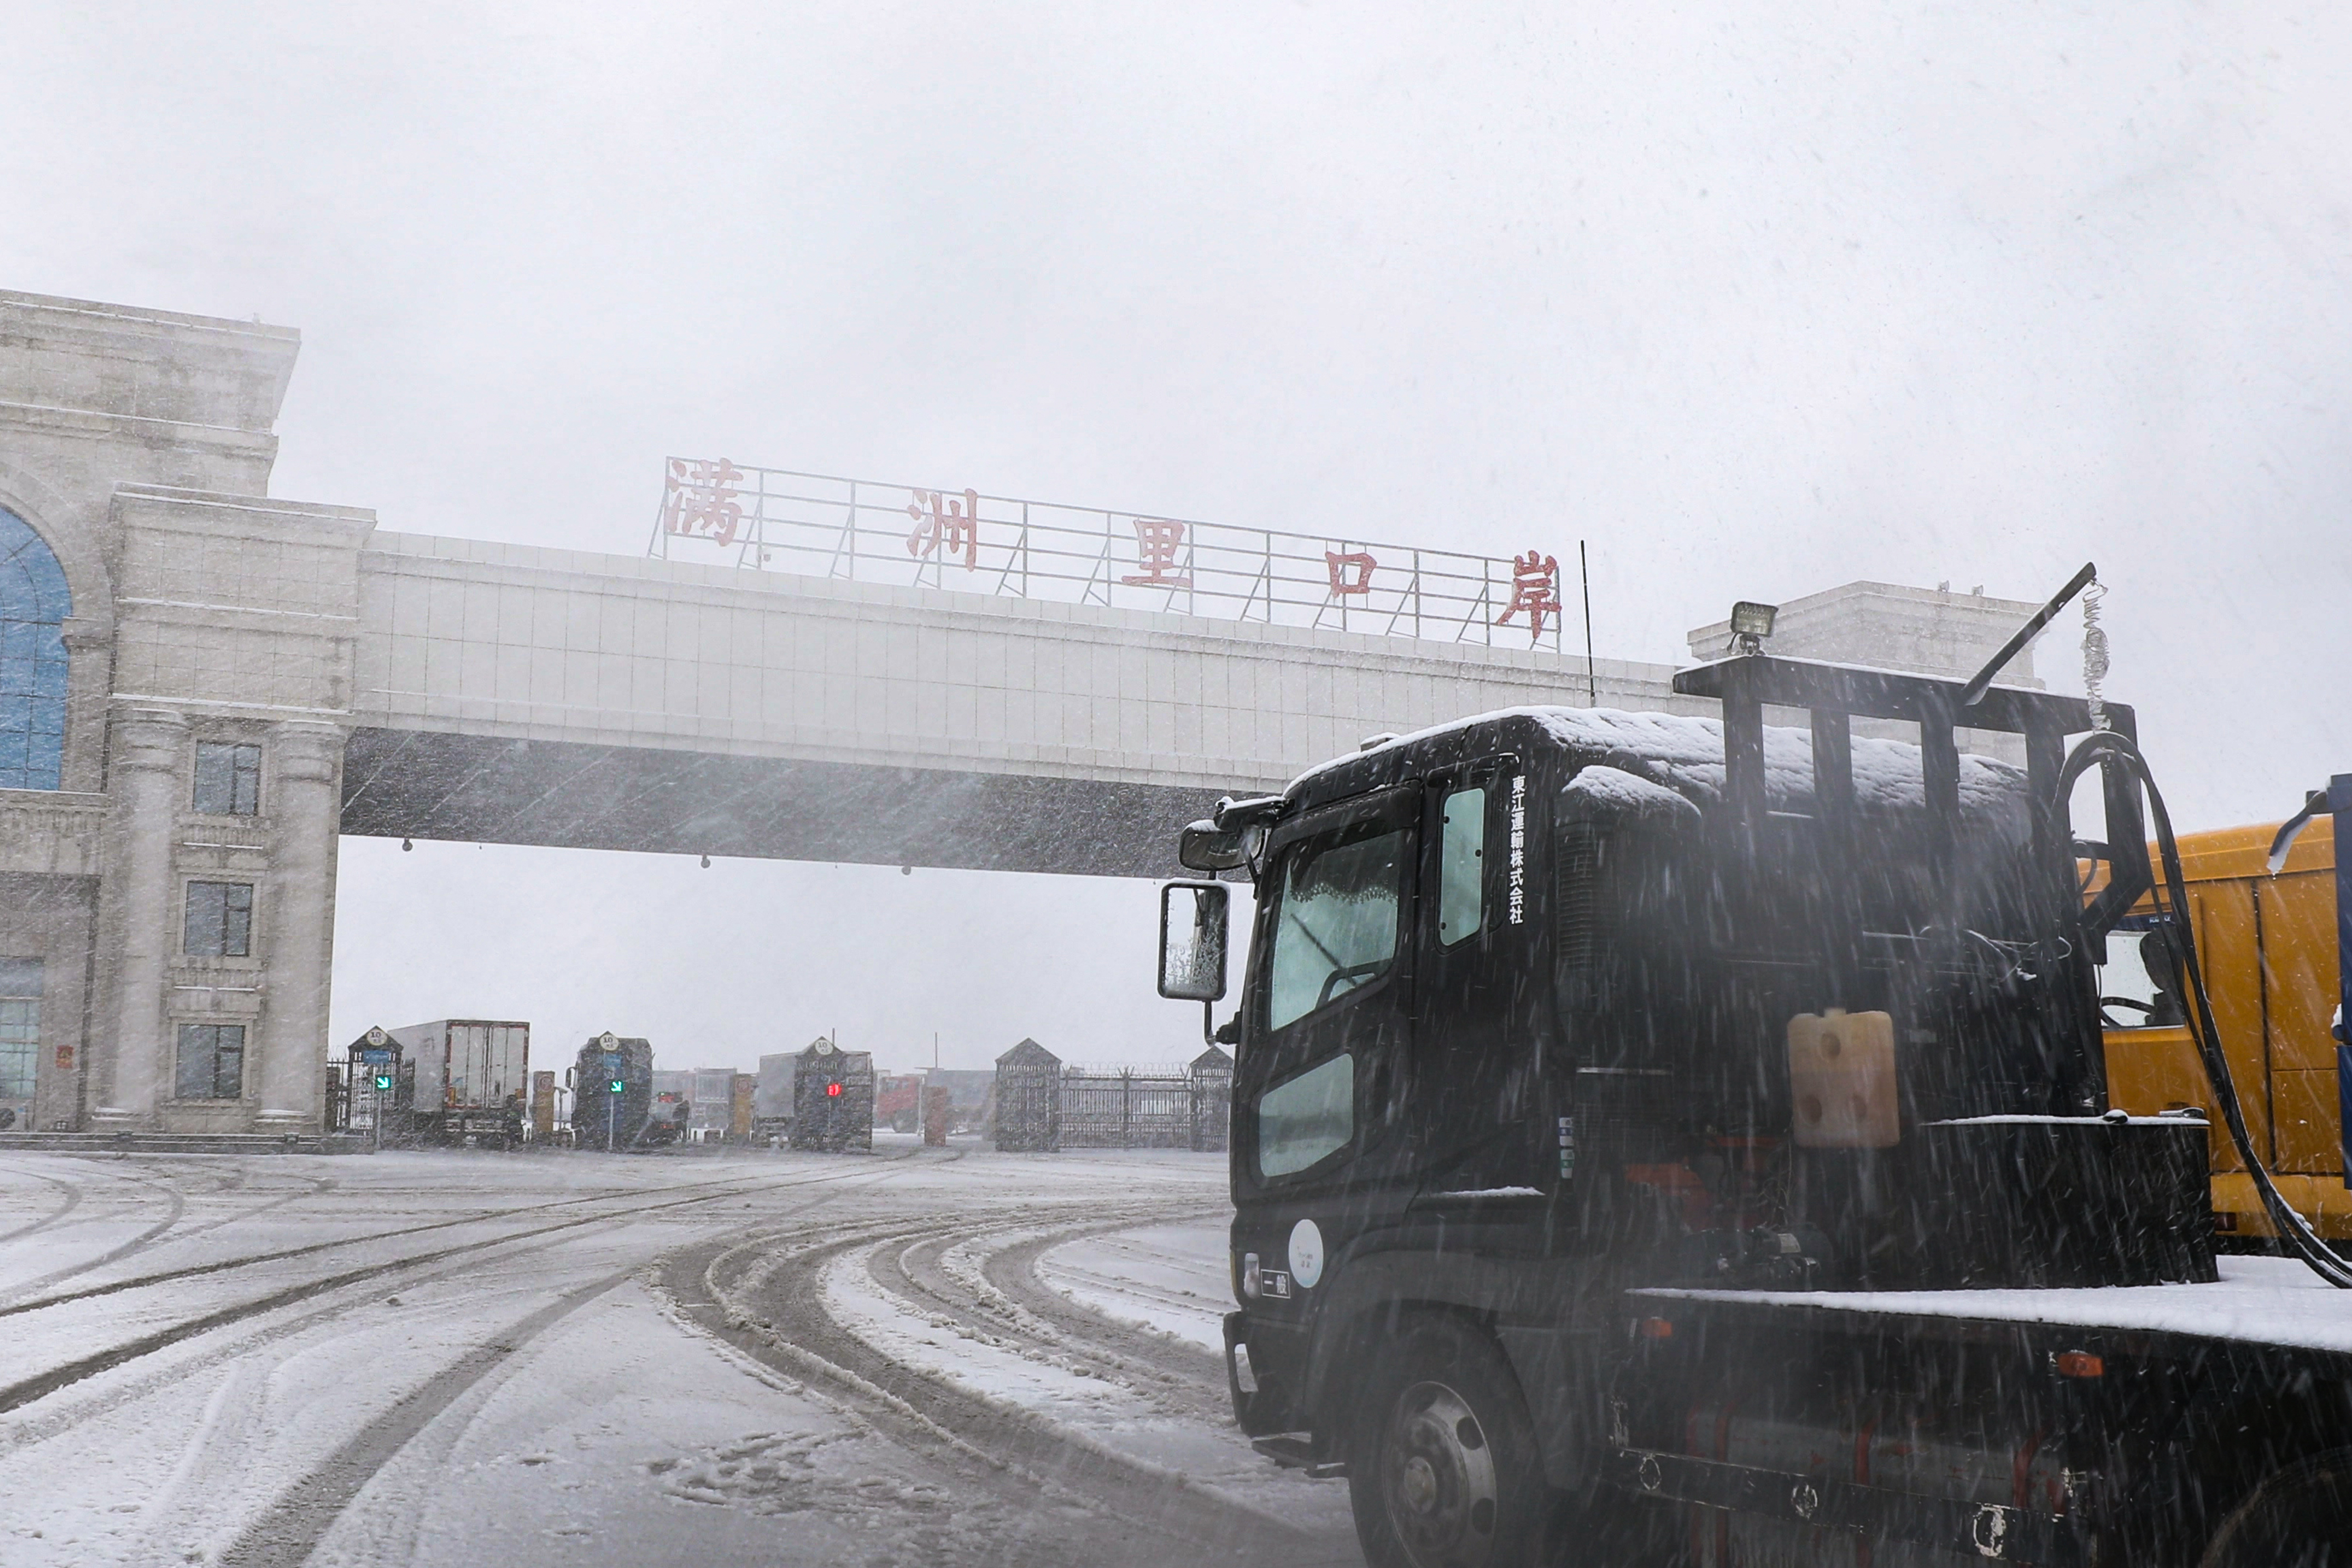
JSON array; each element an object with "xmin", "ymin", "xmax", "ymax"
[{"xmin": 647, "ymin": 458, "xmax": 1562, "ymax": 653}]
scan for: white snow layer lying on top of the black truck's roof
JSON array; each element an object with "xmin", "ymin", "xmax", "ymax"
[{"xmin": 1284, "ymin": 708, "xmax": 2025, "ymax": 820}]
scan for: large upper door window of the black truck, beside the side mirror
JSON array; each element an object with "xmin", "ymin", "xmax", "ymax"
[{"xmin": 1266, "ymin": 823, "xmax": 1404, "ymax": 1030}]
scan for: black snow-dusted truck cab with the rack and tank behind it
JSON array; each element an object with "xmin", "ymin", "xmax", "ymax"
[{"xmin": 1162, "ymin": 656, "xmax": 2277, "ymax": 1568}]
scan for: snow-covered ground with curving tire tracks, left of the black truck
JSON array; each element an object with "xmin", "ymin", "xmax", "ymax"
[{"xmin": 0, "ymin": 1142, "xmax": 1359, "ymax": 1568}]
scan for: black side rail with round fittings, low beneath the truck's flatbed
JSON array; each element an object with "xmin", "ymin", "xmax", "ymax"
[{"xmin": 1602, "ymin": 1448, "xmax": 2084, "ymax": 1563}]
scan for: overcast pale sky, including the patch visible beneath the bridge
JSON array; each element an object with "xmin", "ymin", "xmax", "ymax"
[{"xmin": 0, "ymin": 0, "xmax": 2352, "ymax": 1065}]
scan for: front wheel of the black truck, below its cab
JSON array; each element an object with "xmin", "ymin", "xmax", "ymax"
[{"xmin": 1348, "ymin": 1317, "xmax": 1555, "ymax": 1568}]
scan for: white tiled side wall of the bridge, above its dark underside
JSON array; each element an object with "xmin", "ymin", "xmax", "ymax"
[{"xmin": 355, "ymin": 534, "xmax": 1698, "ymax": 788}]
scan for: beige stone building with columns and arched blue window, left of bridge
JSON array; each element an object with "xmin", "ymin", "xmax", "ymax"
[{"xmin": 0, "ymin": 294, "xmax": 374, "ymax": 1133}]
